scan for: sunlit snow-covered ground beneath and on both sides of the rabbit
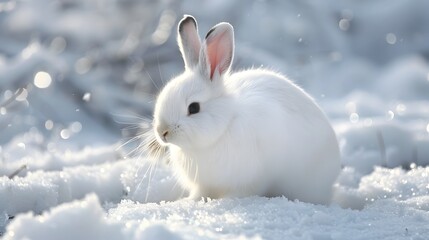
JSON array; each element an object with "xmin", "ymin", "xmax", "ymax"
[{"xmin": 0, "ymin": 148, "xmax": 429, "ymax": 239}]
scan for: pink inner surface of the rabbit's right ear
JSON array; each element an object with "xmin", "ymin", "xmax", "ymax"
[{"xmin": 207, "ymin": 32, "xmax": 232, "ymax": 79}]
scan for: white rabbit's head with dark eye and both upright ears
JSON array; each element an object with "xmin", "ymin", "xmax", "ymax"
[{"xmin": 154, "ymin": 16, "xmax": 234, "ymax": 149}]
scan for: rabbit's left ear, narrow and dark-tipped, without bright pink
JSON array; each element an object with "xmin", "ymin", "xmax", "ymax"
[{"xmin": 177, "ymin": 15, "xmax": 201, "ymax": 69}]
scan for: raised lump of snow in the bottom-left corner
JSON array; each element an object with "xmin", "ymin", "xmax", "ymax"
[{"xmin": 5, "ymin": 195, "xmax": 122, "ymax": 239}]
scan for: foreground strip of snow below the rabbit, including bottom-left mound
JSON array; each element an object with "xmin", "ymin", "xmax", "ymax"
[{"xmin": 6, "ymin": 188, "xmax": 429, "ymax": 239}]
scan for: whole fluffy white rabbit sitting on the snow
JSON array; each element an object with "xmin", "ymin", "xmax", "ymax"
[{"xmin": 153, "ymin": 16, "xmax": 340, "ymax": 204}]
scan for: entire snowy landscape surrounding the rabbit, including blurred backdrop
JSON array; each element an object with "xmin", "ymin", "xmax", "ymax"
[{"xmin": 0, "ymin": 0, "xmax": 429, "ymax": 240}]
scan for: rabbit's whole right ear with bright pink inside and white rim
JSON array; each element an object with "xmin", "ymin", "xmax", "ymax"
[{"xmin": 200, "ymin": 22, "xmax": 234, "ymax": 80}]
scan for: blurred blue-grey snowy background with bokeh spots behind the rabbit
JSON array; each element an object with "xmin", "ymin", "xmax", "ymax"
[{"xmin": 0, "ymin": 0, "xmax": 429, "ymax": 155}]
